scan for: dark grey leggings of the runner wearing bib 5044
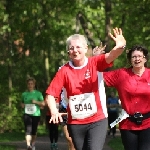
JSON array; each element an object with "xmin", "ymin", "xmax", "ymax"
[{"xmin": 67, "ymin": 119, "xmax": 108, "ymax": 150}]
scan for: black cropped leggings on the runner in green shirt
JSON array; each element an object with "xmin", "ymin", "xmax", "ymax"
[{"xmin": 23, "ymin": 114, "xmax": 40, "ymax": 135}]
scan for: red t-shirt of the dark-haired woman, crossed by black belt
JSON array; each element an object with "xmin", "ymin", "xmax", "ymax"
[{"xmin": 103, "ymin": 68, "xmax": 150, "ymax": 130}]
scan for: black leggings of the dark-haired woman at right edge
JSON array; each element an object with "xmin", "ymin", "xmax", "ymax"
[{"xmin": 120, "ymin": 128, "xmax": 150, "ymax": 150}]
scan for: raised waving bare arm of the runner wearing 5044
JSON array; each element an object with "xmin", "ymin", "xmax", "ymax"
[{"xmin": 105, "ymin": 28, "xmax": 126, "ymax": 64}]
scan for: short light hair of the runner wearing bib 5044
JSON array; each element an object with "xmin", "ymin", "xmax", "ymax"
[{"xmin": 66, "ymin": 34, "xmax": 87, "ymax": 51}]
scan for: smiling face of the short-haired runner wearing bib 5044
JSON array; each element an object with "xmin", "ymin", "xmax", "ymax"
[{"xmin": 68, "ymin": 39, "xmax": 87, "ymax": 61}]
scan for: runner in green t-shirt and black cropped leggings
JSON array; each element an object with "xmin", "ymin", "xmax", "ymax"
[{"xmin": 21, "ymin": 77, "xmax": 45, "ymax": 150}]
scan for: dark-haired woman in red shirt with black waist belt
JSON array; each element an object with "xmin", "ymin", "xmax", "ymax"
[{"xmin": 103, "ymin": 45, "xmax": 150, "ymax": 150}]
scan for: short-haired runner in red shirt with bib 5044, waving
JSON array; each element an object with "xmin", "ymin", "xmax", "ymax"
[{"xmin": 46, "ymin": 28, "xmax": 126, "ymax": 150}]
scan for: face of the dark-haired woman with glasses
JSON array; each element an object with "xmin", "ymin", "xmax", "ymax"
[{"xmin": 131, "ymin": 50, "xmax": 146, "ymax": 68}]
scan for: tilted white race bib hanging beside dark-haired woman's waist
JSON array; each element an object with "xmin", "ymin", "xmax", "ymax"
[{"xmin": 110, "ymin": 109, "xmax": 129, "ymax": 128}]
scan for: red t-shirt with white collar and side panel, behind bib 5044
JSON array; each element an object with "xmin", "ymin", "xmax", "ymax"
[{"xmin": 46, "ymin": 55, "xmax": 112, "ymax": 124}]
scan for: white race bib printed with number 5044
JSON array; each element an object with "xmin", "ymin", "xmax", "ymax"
[{"xmin": 69, "ymin": 93, "xmax": 97, "ymax": 119}]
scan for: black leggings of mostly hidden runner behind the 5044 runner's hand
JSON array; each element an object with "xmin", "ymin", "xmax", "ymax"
[{"xmin": 46, "ymin": 116, "xmax": 58, "ymax": 143}]
